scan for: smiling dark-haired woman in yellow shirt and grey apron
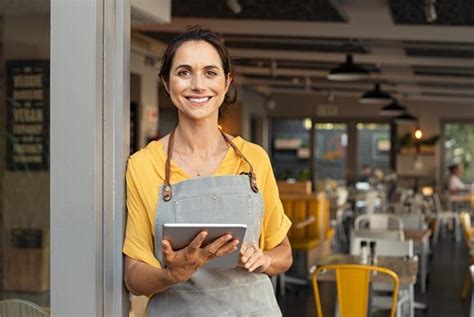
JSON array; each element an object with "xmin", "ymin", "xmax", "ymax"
[{"xmin": 123, "ymin": 27, "xmax": 292, "ymax": 316}]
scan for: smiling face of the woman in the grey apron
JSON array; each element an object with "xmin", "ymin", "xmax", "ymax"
[{"xmin": 167, "ymin": 41, "xmax": 232, "ymax": 120}]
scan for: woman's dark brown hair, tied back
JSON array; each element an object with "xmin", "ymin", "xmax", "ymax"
[{"xmin": 159, "ymin": 25, "xmax": 237, "ymax": 115}]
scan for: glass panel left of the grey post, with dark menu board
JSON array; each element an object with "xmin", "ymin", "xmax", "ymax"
[{"xmin": 0, "ymin": 1, "xmax": 50, "ymax": 309}]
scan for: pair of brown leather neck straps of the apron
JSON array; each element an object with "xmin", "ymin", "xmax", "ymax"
[{"xmin": 163, "ymin": 128, "xmax": 258, "ymax": 201}]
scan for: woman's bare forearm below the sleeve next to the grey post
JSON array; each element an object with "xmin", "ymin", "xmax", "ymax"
[{"xmin": 125, "ymin": 257, "xmax": 175, "ymax": 296}]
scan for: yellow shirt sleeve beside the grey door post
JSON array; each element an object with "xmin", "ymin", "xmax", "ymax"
[{"xmin": 122, "ymin": 159, "xmax": 161, "ymax": 268}]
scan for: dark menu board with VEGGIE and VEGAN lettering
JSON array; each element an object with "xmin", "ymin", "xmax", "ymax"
[{"xmin": 6, "ymin": 60, "xmax": 49, "ymax": 171}]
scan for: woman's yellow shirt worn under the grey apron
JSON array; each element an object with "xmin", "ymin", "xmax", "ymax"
[{"xmin": 123, "ymin": 137, "xmax": 291, "ymax": 268}]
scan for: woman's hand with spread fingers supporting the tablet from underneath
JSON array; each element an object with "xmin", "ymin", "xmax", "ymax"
[{"xmin": 161, "ymin": 231, "xmax": 239, "ymax": 283}]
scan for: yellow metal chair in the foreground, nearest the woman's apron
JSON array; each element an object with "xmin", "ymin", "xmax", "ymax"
[{"xmin": 311, "ymin": 264, "xmax": 400, "ymax": 317}]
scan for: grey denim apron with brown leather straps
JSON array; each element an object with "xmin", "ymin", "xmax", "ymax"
[{"xmin": 147, "ymin": 132, "xmax": 281, "ymax": 317}]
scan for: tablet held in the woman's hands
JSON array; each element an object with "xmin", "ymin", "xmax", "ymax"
[{"xmin": 163, "ymin": 223, "xmax": 247, "ymax": 269}]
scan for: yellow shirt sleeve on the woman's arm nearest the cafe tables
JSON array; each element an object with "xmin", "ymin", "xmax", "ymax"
[{"xmin": 260, "ymin": 154, "xmax": 291, "ymax": 250}]
